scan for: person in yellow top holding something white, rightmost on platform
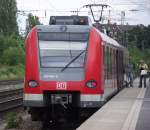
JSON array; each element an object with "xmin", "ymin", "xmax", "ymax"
[{"xmin": 139, "ymin": 60, "xmax": 148, "ymax": 88}]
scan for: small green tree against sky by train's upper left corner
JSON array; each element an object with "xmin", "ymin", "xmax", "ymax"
[{"xmin": 26, "ymin": 13, "xmax": 41, "ymax": 34}]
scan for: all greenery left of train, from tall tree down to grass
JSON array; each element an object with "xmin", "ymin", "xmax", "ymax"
[{"xmin": 0, "ymin": 0, "xmax": 24, "ymax": 80}]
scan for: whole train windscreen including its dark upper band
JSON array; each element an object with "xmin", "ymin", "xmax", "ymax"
[{"xmin": 38, "ymin": 32, "xmax": 88, "ymax": 68}]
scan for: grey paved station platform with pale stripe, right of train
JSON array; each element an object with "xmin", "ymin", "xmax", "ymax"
[{"xmin": 76, "ymin": 78, "xmax": 150, "ymax": 130}]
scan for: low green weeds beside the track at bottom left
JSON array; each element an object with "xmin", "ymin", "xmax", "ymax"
[{"xmin": 6, "ymin": 112, "xmax": 23, "ymax": 129}]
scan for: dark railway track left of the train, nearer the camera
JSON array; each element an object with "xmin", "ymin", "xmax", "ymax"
[{"xmin": 0, "ymin": 88, "xmax": 23, "ymax": 112}]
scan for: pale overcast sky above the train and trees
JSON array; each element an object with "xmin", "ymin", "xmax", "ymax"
[{"xmin": 17, "ymin": 0, "xmax": 150, "ymax": 30}]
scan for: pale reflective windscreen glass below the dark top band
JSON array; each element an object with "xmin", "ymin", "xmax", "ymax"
[{"xmin": 39, "ymin": 40, "xmax": 87, "ymax": 68}]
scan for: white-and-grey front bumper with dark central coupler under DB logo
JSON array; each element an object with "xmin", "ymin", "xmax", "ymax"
[{"xmin": 23, "ymin": 93, "xmax": 104, "ymax": 108}]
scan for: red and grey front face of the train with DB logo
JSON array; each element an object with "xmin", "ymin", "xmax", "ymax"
[{"xmin": 24, "ymin": 20, "xmax": 103, "ymax": 120}]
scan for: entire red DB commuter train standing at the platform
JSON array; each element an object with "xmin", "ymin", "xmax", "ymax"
[{"xmin": 23, "ymin": 16, "xmax": 128, "ymax": 126}]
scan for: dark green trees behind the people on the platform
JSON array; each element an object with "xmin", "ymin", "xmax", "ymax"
[{"xmin": 128, "ymin": 25, "xmax": 150, "ymax": 73}]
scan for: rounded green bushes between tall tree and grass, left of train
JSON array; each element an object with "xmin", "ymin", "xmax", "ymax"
[{"xmin": 0, "ymin": 35, "xmax": 24, "ymax": 65}]
